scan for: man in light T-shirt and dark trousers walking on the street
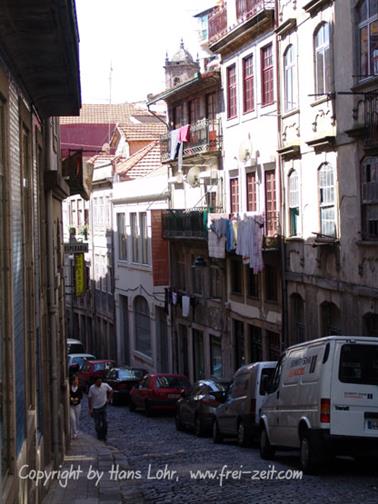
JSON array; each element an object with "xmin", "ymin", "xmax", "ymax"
[{"xmin": 88, "ymin": 378, "xmax": 113, "ymax": 441}]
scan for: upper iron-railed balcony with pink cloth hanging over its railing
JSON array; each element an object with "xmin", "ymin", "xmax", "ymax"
[{"xmin": 160, "ymin": 119, "xmax": 222, "ymax": 162}]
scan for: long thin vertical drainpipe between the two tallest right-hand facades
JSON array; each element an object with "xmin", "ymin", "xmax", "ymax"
[{"xmin": 274, "ymin": 0, "xmax": 288, "ymax": 350}]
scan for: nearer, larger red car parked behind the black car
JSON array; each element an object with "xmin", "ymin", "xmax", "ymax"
[{"xmin": 129, "ymin": 374, "xmax": 192, "ymax": 415}]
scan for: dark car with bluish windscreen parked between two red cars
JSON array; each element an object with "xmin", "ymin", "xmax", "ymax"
[{"xmin": 104, "ymin": 366, "xmax": 147, "ymax": 405}]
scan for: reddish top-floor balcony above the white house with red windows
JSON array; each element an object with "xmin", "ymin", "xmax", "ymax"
[{"xmin": 209, "ymin": 0, "xmax": 275, "ymax": 48}]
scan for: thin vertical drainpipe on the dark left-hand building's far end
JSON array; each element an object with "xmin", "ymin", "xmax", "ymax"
[{"xmin": 46, "ymin": 190, "xmax": 59, "ymax": 467}]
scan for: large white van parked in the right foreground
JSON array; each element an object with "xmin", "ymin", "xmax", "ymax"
[{"xmin": 260, "ymin": 336, "xmax": 378, "ymax": 473}]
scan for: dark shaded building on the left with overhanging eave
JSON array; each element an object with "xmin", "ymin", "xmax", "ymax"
[{"xmin": 0, "ymin": 0, "xmax": 80, "ymax": 504}]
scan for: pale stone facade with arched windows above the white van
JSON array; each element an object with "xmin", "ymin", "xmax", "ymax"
[{"xmin": 277, "ymin": 0, "xmax": 378, "ymax": 344}]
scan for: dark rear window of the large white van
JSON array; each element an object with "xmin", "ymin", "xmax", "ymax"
[{"xmin": 339, "ymin": 345, "xmax": 378, "ymax": 385}]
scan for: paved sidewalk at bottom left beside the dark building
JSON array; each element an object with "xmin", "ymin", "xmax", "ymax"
[{"xmin": 42, "ymin": 433, "xmax": 144, "ymax": 504}]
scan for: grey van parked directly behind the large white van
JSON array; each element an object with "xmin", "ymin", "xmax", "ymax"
[{"xmin": 213, "ymin": 361, "xmax": 277, "ymax": 446}]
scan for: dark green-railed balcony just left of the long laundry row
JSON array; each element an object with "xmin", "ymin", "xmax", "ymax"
[{"xmin": 163, "ymin": 209, "xmax": 208, "ymax": 240}]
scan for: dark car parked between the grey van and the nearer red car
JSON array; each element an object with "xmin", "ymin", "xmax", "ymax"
[{"xmin": 176, "ymin": 378, "xmax": 230, "ymax": 436}]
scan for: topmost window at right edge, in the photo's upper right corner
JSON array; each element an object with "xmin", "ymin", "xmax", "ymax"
[{"xmin": 358, "ymin": 0, "xmax": 378, "ymax": 79}]
